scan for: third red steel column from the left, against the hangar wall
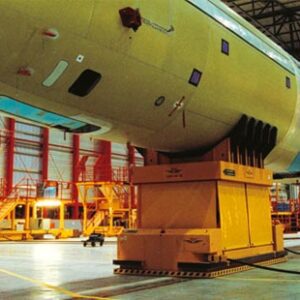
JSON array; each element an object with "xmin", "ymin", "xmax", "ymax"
[{"xmin": 72, "ymin": 134, "xmax": 80, "ymax": 219}]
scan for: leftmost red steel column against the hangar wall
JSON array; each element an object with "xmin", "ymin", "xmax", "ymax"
[{"xmin": 5, "ymin": 118, "xmax": 16, "ymax": 195}]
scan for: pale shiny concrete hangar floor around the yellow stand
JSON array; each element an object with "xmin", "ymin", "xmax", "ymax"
[{"xmin": 0, "ymin": 240, "xmax": 300, "ymax": 300}]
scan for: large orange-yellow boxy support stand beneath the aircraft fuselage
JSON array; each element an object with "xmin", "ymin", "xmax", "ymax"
[{"xmin": 115, "ymin": 161, "xmax": 285, "ymax": 276}]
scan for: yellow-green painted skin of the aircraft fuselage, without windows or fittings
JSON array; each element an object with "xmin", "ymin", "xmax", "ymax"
[{"xmin": 0, "ymin": 0, "xmax": 300, "ymax": 170}]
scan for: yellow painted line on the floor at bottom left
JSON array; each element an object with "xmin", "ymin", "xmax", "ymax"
[{"xmin": 0, "ymin": 269, "xmax": 112, "ymax": 300}]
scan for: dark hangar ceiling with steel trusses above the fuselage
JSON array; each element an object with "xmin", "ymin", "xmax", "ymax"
[{"xmin": 222, "ymin": 0, "xmax": 300, "ymax": 60}]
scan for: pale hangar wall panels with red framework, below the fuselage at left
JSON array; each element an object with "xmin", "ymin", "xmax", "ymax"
[{"xmin": 0, "ymin": 116, "xmax": 143, "ymax": 212}]
